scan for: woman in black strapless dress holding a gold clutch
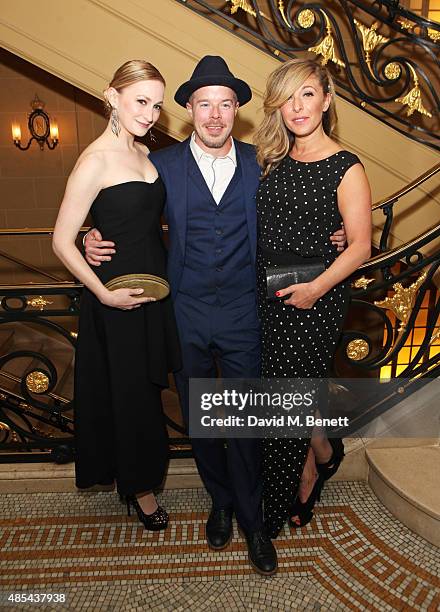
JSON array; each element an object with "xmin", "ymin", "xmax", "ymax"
[{"xmin": 53, "ymin": 60, "xmax": 180, "ymax": 530}]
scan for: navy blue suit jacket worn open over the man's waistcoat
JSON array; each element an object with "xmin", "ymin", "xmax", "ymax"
[{"xmin": 150, "ymin": 138, "xmax": 260, "ymax": 297}]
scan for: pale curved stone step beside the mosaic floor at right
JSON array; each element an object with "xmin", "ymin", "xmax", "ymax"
[{"xmin": 366, "ymin": 446, "xmax": 440, "ymax": 546}]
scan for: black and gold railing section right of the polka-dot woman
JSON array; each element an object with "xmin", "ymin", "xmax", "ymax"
[{"xmin": 334, "ymin": 164, "xmax": 440, "ymax": 431}]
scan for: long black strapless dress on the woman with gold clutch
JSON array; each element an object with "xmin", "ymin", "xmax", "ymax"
[{"xmin": 75, "ymin": 177, "xmax": 181, "ymax": 495}]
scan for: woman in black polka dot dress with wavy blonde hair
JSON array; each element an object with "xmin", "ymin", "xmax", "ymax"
[{"xmin": 255, "ymin": 60, "xmax": 371, "ymax": 537}]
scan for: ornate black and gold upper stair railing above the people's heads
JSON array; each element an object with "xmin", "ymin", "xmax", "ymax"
[{"xmin": 176, "ymin": 0, "xmax": 440, "ymax": 149}]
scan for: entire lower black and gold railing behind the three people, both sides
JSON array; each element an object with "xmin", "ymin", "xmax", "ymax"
[{"xmin": 0, "ymin": 158, "xmax": 440, "ymax": 462}]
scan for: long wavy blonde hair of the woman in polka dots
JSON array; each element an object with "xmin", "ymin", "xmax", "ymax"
[{"xmin": 254, "ymin": 59, "xmax": 337, "ymax": 179}]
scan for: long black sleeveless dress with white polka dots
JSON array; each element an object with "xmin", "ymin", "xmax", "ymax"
[{"xmin": 257, "ymin": 151, "xmax": 360, "ymax": 537}]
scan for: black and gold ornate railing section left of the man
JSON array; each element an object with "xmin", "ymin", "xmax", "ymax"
[{"xmin": 0, "ymin": 241, "xmax": 190, "ymax": 463}]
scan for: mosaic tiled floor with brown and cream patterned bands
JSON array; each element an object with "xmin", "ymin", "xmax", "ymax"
[{"xmin": 0, "ymin": 482, "xmax": 440, "ymax": 612}]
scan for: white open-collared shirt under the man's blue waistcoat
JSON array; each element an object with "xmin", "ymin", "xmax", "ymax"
[{"xmin": 190, "ymin": 132, "xmax": 237, "ymax": 204}]
